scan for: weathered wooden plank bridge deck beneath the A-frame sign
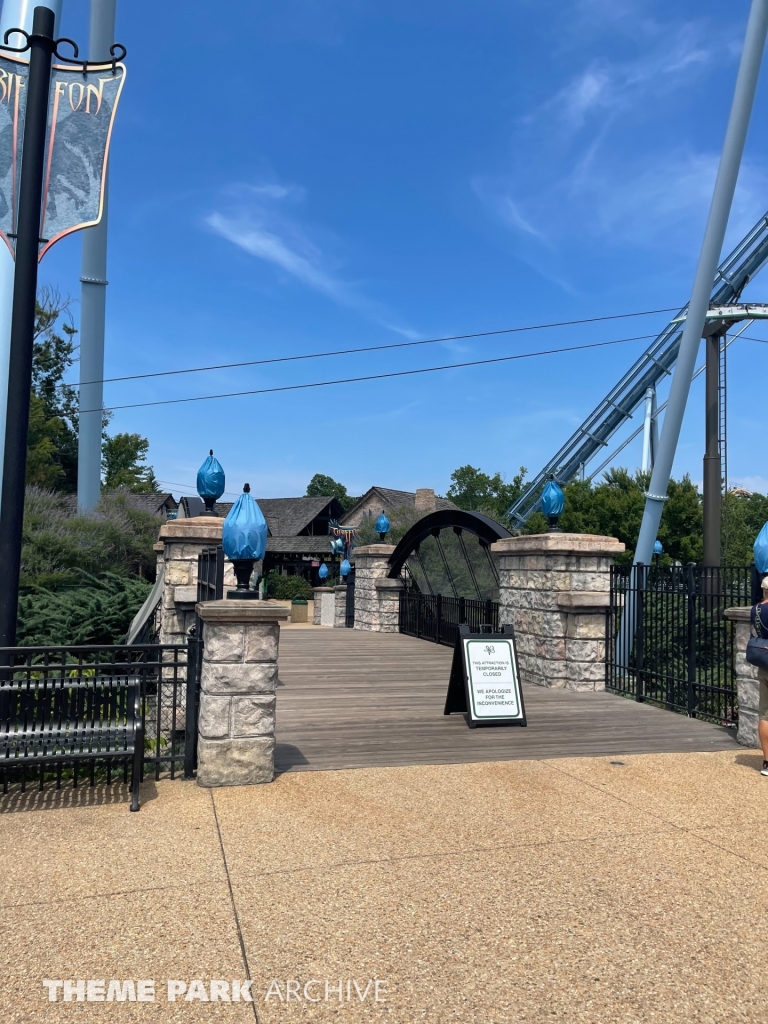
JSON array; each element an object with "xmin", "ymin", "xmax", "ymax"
[{"xmin": 275, "ymin": 628, "xmax": 737, "ymax": 771}]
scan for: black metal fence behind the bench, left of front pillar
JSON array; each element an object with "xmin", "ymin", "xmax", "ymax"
[{"xmin": 0, "ymin": 637, "xmax": 203, "ymax": 792}]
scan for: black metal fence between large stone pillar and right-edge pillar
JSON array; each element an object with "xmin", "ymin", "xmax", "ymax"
[{"xmin": 605, "ymin": 564, "xmax": 754, "ymax": 726}]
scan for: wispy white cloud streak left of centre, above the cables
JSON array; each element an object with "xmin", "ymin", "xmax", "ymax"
[{"xmin": 205, "ymin": 182, "xmax": 420, "ymax": 339}]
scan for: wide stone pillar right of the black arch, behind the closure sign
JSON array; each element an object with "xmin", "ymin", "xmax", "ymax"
[{"xmin": 490, "ymin": 534, "xmax": 625, "ymax": 690}]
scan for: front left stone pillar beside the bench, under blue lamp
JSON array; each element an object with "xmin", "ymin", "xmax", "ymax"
[{"xmin": 197, "ymin": 599, "xmax": 291, "ymax": 786}]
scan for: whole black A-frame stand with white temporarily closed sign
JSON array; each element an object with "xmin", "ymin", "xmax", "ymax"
[{"xmin": 443, "ymin": 626, "xmax": 527, "ymax": 729}]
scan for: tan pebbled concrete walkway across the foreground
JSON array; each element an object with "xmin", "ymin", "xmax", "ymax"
[{"xmin": 0, "ymin": 751, "xmax": 768, "ymax": 1024}]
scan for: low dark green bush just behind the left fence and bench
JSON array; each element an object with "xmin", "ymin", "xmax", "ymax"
[{"xmin": 16, "ymin": 572, "xmax": 152, "ymax": 646}]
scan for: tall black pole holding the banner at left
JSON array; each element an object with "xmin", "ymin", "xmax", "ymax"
[{"xmin": 0, "ymin": 7, "xmax": 55, "ymax": 647}]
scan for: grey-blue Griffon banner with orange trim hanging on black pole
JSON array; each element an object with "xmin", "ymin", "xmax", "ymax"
[{"xmin": 0, "ymin": 54, "xmax": 125, "ymax": 259}]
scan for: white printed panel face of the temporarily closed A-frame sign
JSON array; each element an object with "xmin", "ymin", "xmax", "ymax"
[{"xmin": 463, "ymin": 637, "xmax": 525, "ymax": 722}]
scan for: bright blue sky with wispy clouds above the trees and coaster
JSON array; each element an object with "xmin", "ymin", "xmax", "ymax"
[{"xmin": 34, "ymin": 0, "xmax": 768, "ymax": 496}]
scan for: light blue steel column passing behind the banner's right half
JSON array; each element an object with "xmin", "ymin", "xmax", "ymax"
[{"xmin": 78, "ymin": 0, "xmax": 117, "ymax": 512}]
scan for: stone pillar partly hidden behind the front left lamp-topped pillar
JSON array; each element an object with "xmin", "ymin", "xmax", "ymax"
[{"xmin": 155, "ymin": 516, "xmax": 236, "ymax": 643}]
